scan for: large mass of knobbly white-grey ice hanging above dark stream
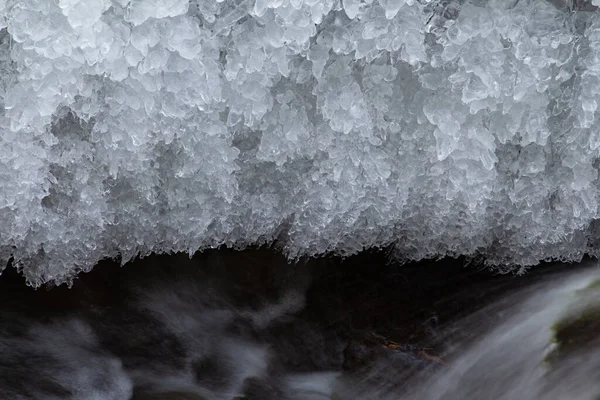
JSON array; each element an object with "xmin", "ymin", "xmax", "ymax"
[{"xmin": 0, "ymin": 0, "xmax": 600, "ymax": 286}]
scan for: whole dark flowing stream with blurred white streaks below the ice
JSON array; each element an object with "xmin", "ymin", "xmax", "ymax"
[{"xmin": 0, "ymin": 252, "xmax": 600, "ymax": 400}]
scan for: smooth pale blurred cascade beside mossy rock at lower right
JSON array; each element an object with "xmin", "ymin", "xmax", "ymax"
[{"xmin": 403, "ymin": 268, "xmax": 600, "ymax": 400}]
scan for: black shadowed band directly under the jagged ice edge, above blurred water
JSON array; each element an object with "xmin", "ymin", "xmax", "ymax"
[{"xmin": 0, "ymin": 248, "xmax": 589, "ymax": 342}]
